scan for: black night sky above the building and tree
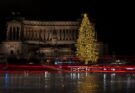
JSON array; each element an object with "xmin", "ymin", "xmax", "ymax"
[{"xmin": 0, "ymin": 0, "xmax": 135, "ymax": 55}]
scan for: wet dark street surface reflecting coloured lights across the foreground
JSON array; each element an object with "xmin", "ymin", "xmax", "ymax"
[{"xmin": 0, "ymin": 71, "xmax": 135, "ymax": 93}]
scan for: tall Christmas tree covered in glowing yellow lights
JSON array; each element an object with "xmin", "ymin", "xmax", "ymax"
[{"xmin": 76, "ymin": 14, "xmax": 99, "ymax": 64}]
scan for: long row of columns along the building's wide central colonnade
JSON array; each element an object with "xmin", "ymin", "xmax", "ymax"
[{"xmin": 24, "ymin": 29, "xmax": 78, "ymax": 40}]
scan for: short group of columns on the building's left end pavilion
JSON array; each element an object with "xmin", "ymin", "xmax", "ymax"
[{"xmin": 7, "ymin": 26, "xmax": 21, "ymax": 40}]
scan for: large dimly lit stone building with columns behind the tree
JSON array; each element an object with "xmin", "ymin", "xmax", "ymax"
[{"xmin": 1, "ymin": 18, "xmax": 104, "ymax": 60}]
